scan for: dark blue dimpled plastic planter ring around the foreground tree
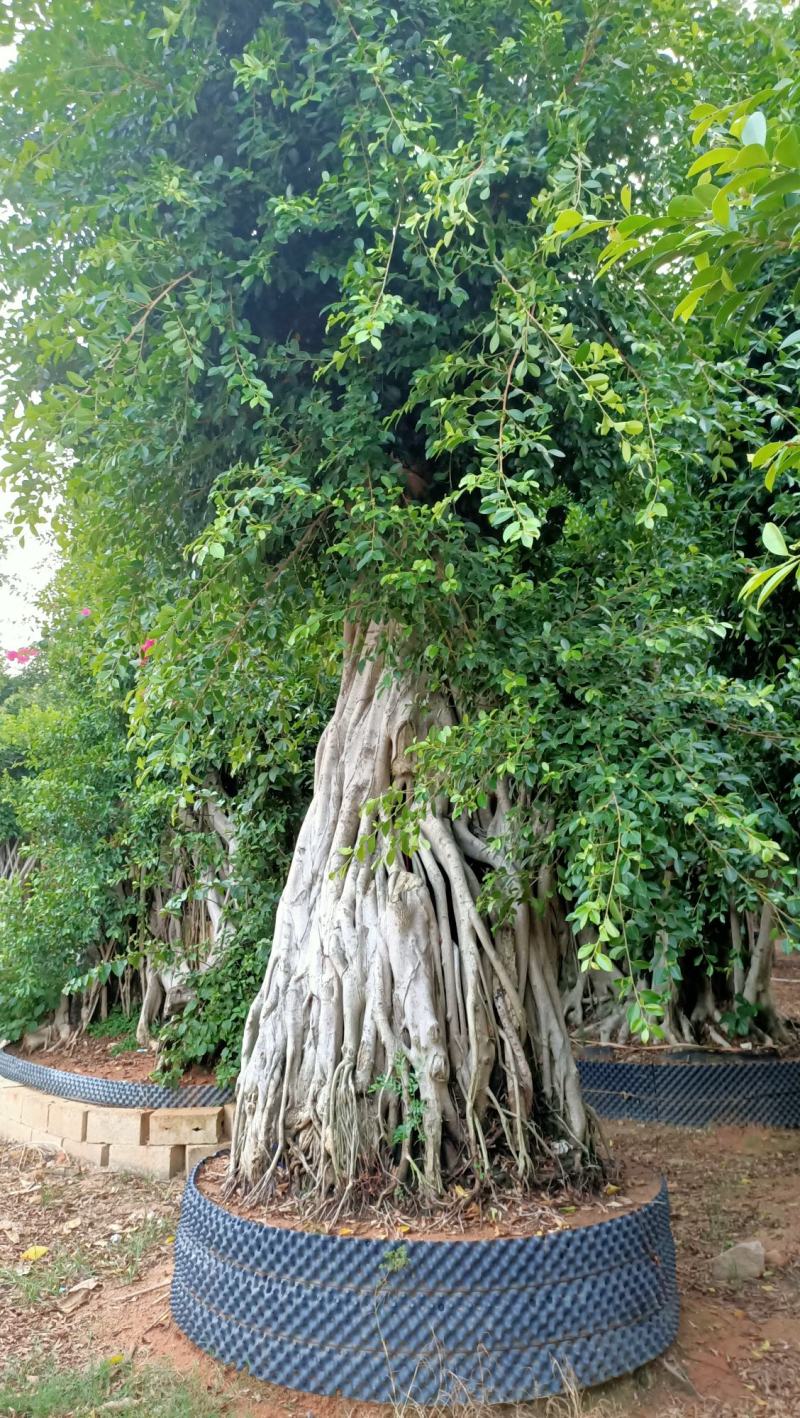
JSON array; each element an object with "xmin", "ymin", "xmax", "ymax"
[{"xmin": 172, "ymin": 1164, "xmax": 678, "ymax": 1404}]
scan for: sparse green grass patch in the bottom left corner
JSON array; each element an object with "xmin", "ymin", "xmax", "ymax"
[{"xmin": 0, "ymin": 1360, "xmax": 223, "ymax": 1418}]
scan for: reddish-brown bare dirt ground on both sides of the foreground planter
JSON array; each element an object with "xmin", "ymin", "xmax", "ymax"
[{"xmin": 0, "ymin": 1124, "xmax": 800, "ymax": 1418}]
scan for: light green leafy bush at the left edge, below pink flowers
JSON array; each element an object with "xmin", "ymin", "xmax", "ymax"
[{"xmin": 0, "ymin": 647, "xmax": 129, "ymax": 1039}]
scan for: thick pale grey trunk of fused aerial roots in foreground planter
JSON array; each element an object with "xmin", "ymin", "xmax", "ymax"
[{"xmin": 231, "ymin": 627, "xmax": 590, "ymax": 1195}]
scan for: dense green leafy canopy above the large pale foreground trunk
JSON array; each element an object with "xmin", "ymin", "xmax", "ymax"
[{"xmin": 0, "ymin": 0, "xmax": 800, "ymax": 1054}]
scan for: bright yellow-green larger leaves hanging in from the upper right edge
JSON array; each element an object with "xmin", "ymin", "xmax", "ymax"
[{"xmin": 590, "ymin": 55, "xmax": 800, "ymax": 610}]
